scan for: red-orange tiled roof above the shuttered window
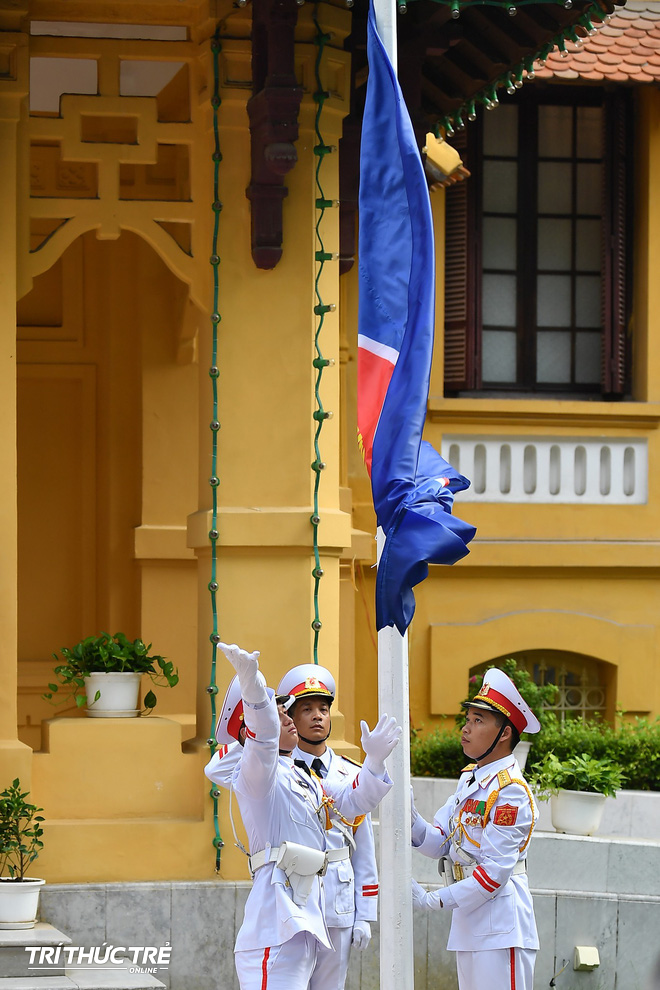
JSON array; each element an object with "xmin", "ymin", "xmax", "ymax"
[{"xmin": 534, "ymin": 0, "xmax": 660, "ymax": 83}]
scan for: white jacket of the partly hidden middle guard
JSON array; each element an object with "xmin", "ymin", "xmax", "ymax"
[{"xmin": 293, "ymin": 747, "xmax": 378, "ymax": 928}]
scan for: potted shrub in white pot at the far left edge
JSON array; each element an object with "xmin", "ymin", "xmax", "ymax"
[{"xmin": 0, "ymin": 777, "xmax": 46, "ymax": 928}]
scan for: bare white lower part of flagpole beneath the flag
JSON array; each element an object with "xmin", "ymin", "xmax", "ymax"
[{"xmin": 376, "ymin": 527, "xmax": 414, "ymax": 990}]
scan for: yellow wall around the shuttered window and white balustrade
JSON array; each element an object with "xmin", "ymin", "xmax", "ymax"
[{"xmin": 351, "ymin": 88, "xmax": 660, "ymax": 730}]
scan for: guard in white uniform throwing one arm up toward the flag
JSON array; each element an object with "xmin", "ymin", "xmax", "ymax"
[{"xmin": 205, "ymin": 643, "xmax": 401, "ymax": 990}]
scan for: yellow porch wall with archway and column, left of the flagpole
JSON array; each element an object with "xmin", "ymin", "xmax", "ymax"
[{"xmin": 0, "ymin": 3, "xmax": 361, "ymax": 882}]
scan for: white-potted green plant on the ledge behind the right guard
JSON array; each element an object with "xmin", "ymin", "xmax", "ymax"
[{"xmin": 529, "ymin": 753, "xmax": 626, "ymax": 835}]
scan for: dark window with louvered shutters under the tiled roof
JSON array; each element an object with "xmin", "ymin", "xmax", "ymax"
[{"xmin": 445, "ymin": 86, "xmax": 632, "ymax": 398}]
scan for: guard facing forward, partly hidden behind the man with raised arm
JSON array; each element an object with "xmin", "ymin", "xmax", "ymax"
[{"xmin": 277, "ymin": 663, "xmax": 378, "ymax": 990}]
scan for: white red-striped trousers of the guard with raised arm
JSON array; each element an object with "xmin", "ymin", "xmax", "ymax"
[{"xmin": 234, "ymin": 932, "xmax": 320, "ymax": 990}]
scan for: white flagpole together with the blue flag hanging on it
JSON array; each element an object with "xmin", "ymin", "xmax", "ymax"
[{"xmin": 358, "ymin": 0, "xmax": 475, "ymax": 990}]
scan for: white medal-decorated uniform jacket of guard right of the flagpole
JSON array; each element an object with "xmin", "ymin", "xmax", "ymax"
[{"xmin": 412, "ymin": 755, "xmax": 539, "ymax": 952}]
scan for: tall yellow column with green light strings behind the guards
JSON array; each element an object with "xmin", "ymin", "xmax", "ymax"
[{"xmin": 188, "ymin": 5, "xmax": 351, "ymax": 740}]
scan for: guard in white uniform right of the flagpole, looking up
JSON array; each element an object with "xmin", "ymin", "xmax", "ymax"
[{"xmin": 412, "ymin": 668, "xmax": 540, "ymax": 990}]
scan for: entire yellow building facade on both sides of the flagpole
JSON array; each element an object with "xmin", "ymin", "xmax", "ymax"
[{"xmin": 0, "ymin": 0, "xmax": 660, "ymax": 882}]
